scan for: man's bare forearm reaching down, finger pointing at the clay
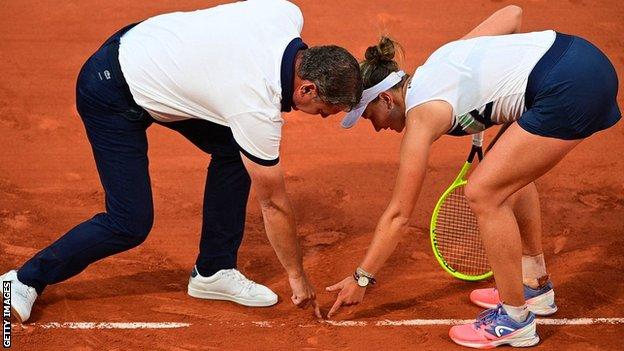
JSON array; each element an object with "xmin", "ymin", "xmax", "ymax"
[{"xmin": 241, "ymin": 154, "xmax": 321, "ymax": 318}]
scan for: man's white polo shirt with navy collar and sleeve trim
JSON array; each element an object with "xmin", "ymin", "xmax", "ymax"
[{"xmin": 119, "ymin": 0, "xmax": 306, "ymax": 165}]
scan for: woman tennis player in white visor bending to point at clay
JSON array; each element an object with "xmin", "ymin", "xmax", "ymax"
[{"xmin": 327, "ymin": 6, "xmax": 621, "ymax": 348}]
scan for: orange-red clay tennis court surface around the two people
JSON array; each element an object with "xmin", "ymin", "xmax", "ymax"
[{"xmin": 0, "ymin": 0, "xmax": 624, "ymax": 350}]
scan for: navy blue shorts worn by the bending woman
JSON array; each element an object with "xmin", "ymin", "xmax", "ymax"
[{"xmin": 518, "ymin": 33, "xmax": 621, "ymax": 140}]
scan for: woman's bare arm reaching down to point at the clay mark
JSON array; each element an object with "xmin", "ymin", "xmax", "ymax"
[{"xmin": 327, "ymin": 101, "xmax": 452, "ymax": 318}]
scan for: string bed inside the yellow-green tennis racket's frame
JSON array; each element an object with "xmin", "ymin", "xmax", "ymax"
[{"xmin": 435, "ymin": 186, "xmax": 490, "ymax": 276}]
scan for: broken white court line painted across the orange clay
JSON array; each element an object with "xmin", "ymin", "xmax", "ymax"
[{"xmin": 25, "ymin": 318, "xmax": 624, "ymax": 329}]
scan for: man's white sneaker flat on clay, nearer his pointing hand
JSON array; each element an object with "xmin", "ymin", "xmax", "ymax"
[{"xmin": 188, "ymin": 267, "xmax": 277, "ymax": 307}]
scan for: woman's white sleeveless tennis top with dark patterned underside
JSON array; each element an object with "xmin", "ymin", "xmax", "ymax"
[{"xmin": 405, "ymin": 30, "xmax": 556, "ymax": 135}]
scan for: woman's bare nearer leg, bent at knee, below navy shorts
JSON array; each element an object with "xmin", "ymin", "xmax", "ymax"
[{"xmin": 466, "ymin": 124, "xmax": 581, "ymax": 306}]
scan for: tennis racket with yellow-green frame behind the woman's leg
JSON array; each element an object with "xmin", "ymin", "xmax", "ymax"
[{"xmin": 429, "ymin": 124, "xmax": 510, "ymax": 281}]
